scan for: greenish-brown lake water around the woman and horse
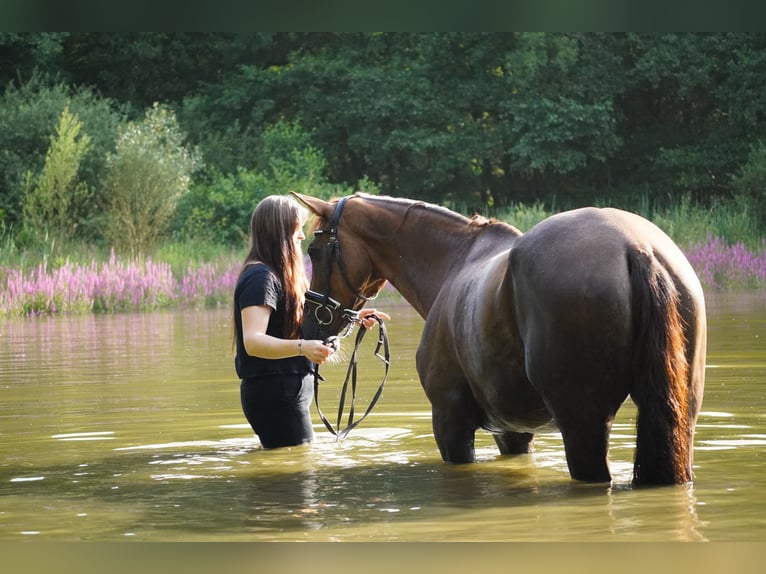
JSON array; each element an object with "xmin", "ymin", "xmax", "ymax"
[{"xmin": 0, "ymin": 293, "xmax": 766, "ymax": 541}]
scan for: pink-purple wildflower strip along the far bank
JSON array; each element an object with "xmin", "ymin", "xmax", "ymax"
[{"xmin": 0, "ymin": 237, "xmax": 766, "ymax": 317}]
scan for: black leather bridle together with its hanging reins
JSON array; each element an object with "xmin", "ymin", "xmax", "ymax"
[{"xmin": 305, "ymin": 195, "xmax": 391, "ymax": 440}]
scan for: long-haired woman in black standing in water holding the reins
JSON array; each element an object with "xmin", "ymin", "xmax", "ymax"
[{"xmin": 234, "ymin": 195, "xmax": 389, "ymax": 448}]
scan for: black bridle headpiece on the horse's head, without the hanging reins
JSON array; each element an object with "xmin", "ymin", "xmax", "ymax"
[{"xmin": 305, "ymin": 195, "xmax": 377, "ymax": 338}]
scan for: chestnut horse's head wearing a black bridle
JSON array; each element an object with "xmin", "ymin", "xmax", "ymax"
[{"xmin": 291, "ymin": 192, "xmax": 386, "ymax": 339}]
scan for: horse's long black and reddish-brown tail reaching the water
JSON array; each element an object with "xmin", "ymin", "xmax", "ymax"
[{"xmin": 628, "ymin": 252, "xmax": 692, "ymax": 484}]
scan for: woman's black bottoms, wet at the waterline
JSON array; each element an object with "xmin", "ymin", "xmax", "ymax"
[{"xmin": 240, "ymin": 374, "xmax": 314, "ymax": 448}]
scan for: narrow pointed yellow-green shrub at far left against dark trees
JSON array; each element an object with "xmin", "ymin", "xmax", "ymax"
[{"xmin": 23, "ymin": 107, "xmax": 90, "ymax": 245}]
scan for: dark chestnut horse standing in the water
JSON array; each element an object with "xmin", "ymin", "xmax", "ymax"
[{"xmin": 295, "ymin": 194, "xmax": 707, "ymax": 484}]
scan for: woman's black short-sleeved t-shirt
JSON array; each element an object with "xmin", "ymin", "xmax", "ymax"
[{"xmin": 234, "ymin": 263, "xmax": 311, "ymax": 379}]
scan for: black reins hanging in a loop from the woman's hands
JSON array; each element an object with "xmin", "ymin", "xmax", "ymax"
[{"xmin": 314, "ymin": 315, "xmax": 391, "ymax": 441}]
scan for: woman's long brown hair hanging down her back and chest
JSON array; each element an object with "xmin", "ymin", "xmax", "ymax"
[{"xmin": 234, "ymin": 195, "xmax": 309, "ymax": 338}]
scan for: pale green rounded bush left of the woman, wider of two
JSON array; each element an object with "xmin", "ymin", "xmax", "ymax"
[{"xmin": 104, "ymin": 104, "xmax": 200, "ymax": 255}]
